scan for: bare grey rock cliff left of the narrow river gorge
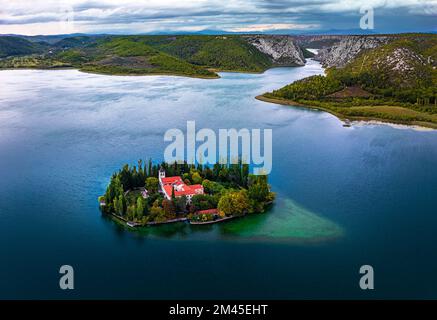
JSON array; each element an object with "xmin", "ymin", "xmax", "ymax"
[{"xmin": 244, "ymin": 35, "xmax": 306, "ymax": 66}]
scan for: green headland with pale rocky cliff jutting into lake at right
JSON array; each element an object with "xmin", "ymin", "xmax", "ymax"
[{"xmin": 257, "ymin": 34, "xmax": 437, "ymax": 129}]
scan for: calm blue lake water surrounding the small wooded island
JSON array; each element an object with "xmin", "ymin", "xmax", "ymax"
[{"xmin": 0, "ymin": 61, "xmax": 437, "ymax": 299}]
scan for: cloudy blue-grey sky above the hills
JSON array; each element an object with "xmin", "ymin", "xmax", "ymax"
[{"xmin": 0, "ymin": 0, "xmax": 437, "ymax": 35}]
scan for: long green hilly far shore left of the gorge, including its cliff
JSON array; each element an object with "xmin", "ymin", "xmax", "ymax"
[{"xmin": 0, "ymin": 35, "xmax": 306, "ymax": 78}]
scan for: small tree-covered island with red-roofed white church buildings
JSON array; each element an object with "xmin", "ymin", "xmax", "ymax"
[{"xmin": 99, "ymin": 160, "xmax": 275, "ymax": 228}]
